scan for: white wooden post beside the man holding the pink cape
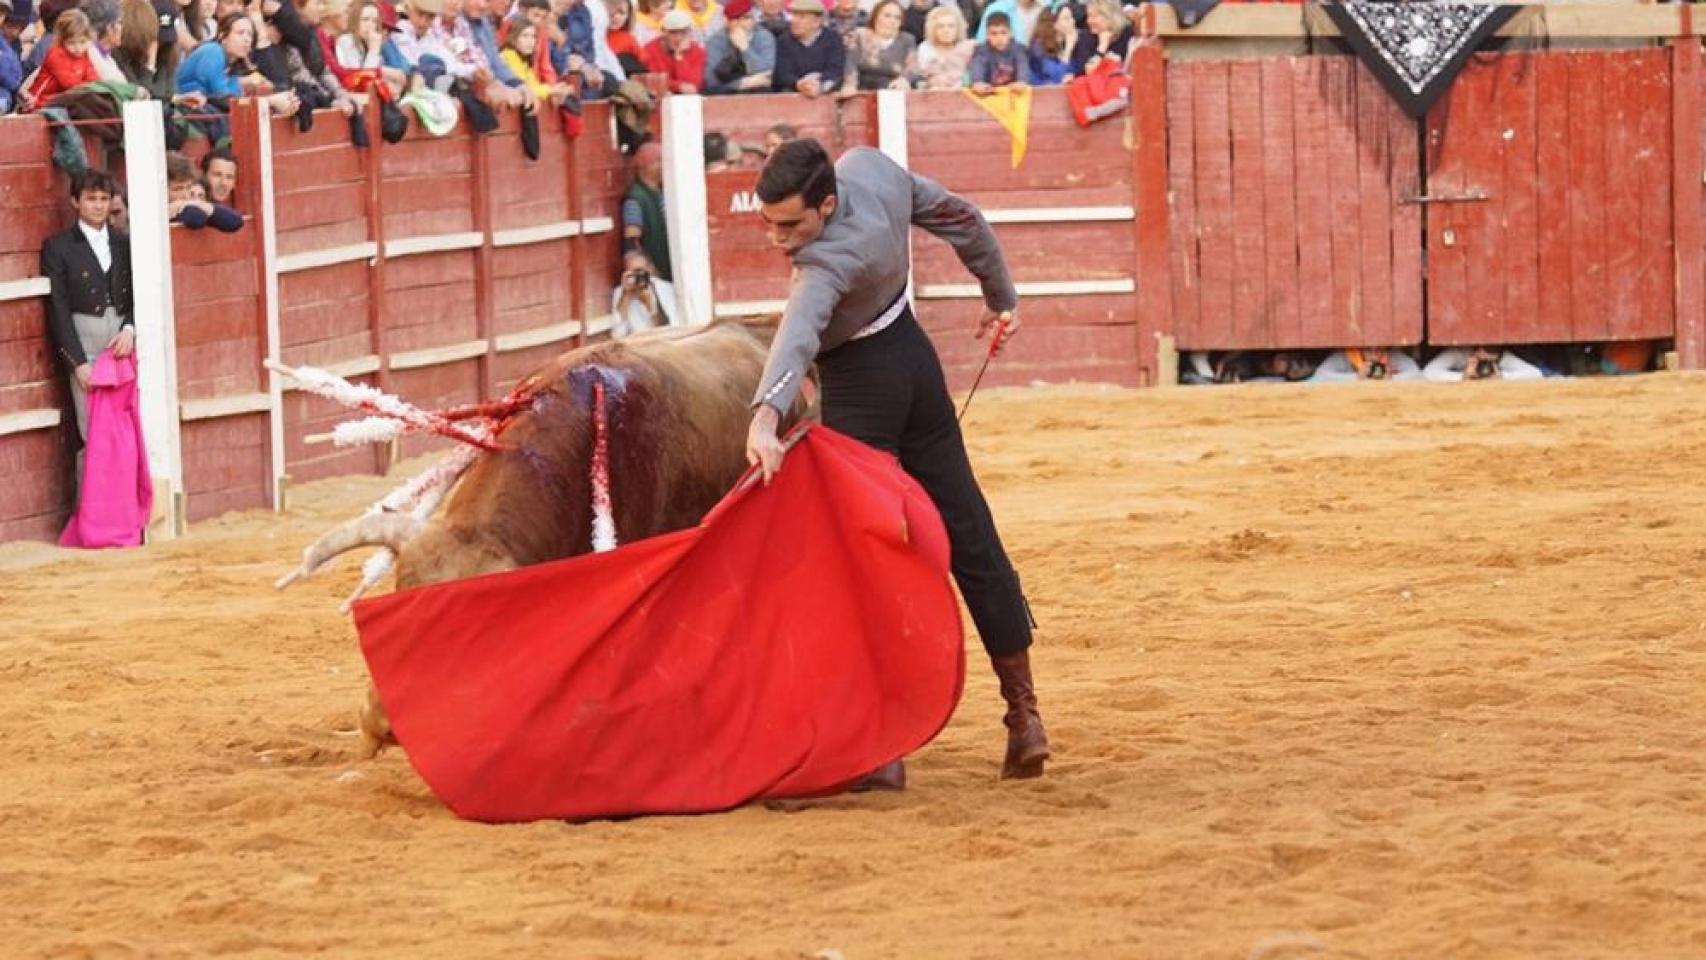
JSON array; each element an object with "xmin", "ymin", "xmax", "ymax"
[{"xmin": 125, "ymin": 101, "xmax": 186, "ymax": 541}]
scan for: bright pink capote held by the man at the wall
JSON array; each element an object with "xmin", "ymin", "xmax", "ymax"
[{"xmin": 60, "ymin": 350, "xmax": 154, "ymax": 547}]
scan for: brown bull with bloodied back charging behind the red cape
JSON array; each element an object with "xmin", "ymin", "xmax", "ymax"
[{"xmin": 286, "ymin": 322, "xmax": 800, "ymax": 757}]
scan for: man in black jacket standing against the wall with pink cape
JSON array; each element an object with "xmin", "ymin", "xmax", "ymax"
[{"xmin": 41, "ymin": 171, "xmax": 136, "ymax": 446}]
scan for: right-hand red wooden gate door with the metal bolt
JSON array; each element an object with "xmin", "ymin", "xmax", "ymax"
[{"xmin": 1418, "ymin": 48, "xmax": 1677, "ymax": 344}]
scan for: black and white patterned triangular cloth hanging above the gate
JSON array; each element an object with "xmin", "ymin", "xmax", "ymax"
[{"xmin": 1324, "ymin": 0, "xmax": 1522, "ymax": 119}]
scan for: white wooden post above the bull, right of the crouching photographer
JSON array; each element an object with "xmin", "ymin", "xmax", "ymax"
[{"xmin": 664, "ymin": 94, "xmax": 713, "ymax": 326}]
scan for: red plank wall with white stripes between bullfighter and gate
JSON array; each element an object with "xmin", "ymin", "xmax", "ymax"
[{"xmin": 906, "ymin": 87, "xmax": 1140, "ymax": 389}]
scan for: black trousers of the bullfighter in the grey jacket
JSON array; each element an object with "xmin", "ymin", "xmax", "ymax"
[{"xmin": 817, "ymin": 307, "xmax": 1032, "ymax": 656}]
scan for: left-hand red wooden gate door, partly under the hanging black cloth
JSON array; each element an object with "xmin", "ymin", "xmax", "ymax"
[{"xmin": 1167, "ymin": 56, "xmax": 1423, "ymax": 350}]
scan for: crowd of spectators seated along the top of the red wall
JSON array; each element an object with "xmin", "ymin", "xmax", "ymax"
[{"xmin": 0, "ymin": 0, "xmax": 1133, "ymax": 132}]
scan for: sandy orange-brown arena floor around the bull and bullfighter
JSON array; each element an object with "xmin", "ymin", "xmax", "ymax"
[{"xmin": 0, "ymin": 375, "xmax": 1706, "ymax": 960}]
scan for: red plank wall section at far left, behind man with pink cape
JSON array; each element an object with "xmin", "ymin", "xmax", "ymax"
[{"xmin": 0, "ymin": 116, "xmax": 75, "ymax": 542}]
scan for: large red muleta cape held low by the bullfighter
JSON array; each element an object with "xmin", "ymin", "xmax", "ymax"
[{"xmin": 355, "ymin": 426, "xmax": 966, "ymax": 822}]
